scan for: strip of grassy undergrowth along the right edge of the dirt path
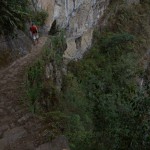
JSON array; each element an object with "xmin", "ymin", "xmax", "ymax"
[{"xmin": 25, "ymin": 30, "xmax": 67, "ymax": 140}]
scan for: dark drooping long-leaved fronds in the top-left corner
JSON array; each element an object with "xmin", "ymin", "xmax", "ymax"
[{"xmin": 0, "ymin": 0, "xmax": 28, "ymax": 34}]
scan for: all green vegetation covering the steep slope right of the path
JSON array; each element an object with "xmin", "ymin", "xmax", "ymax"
[{"xmin": 27, "ymin": 0, "xmax": 150, "ymax": 150}]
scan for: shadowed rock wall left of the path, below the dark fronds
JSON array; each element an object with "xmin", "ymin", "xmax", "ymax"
[{"xmin": 0, "ymin": 31, "xmax": 32, "ymax": 69}]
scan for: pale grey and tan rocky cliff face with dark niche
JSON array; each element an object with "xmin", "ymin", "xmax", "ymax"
[{"xmin": 34, "ymin": 0, "xmax": 109, "ymax": 59}]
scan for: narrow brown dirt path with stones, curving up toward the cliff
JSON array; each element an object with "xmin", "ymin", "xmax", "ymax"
[{"xmin": 0, "ymin": 37, "xmax": 47, "ymax": 150}]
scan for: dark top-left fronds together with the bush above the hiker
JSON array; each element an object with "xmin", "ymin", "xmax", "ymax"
[{"xmin": 0, "ymin": 0, "xmax": 48, "ymax": 35}]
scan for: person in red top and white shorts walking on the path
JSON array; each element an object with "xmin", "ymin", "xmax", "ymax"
[{"xmin": 30, "ymin": 23, "xmax": 39, "ymax": 45}]
